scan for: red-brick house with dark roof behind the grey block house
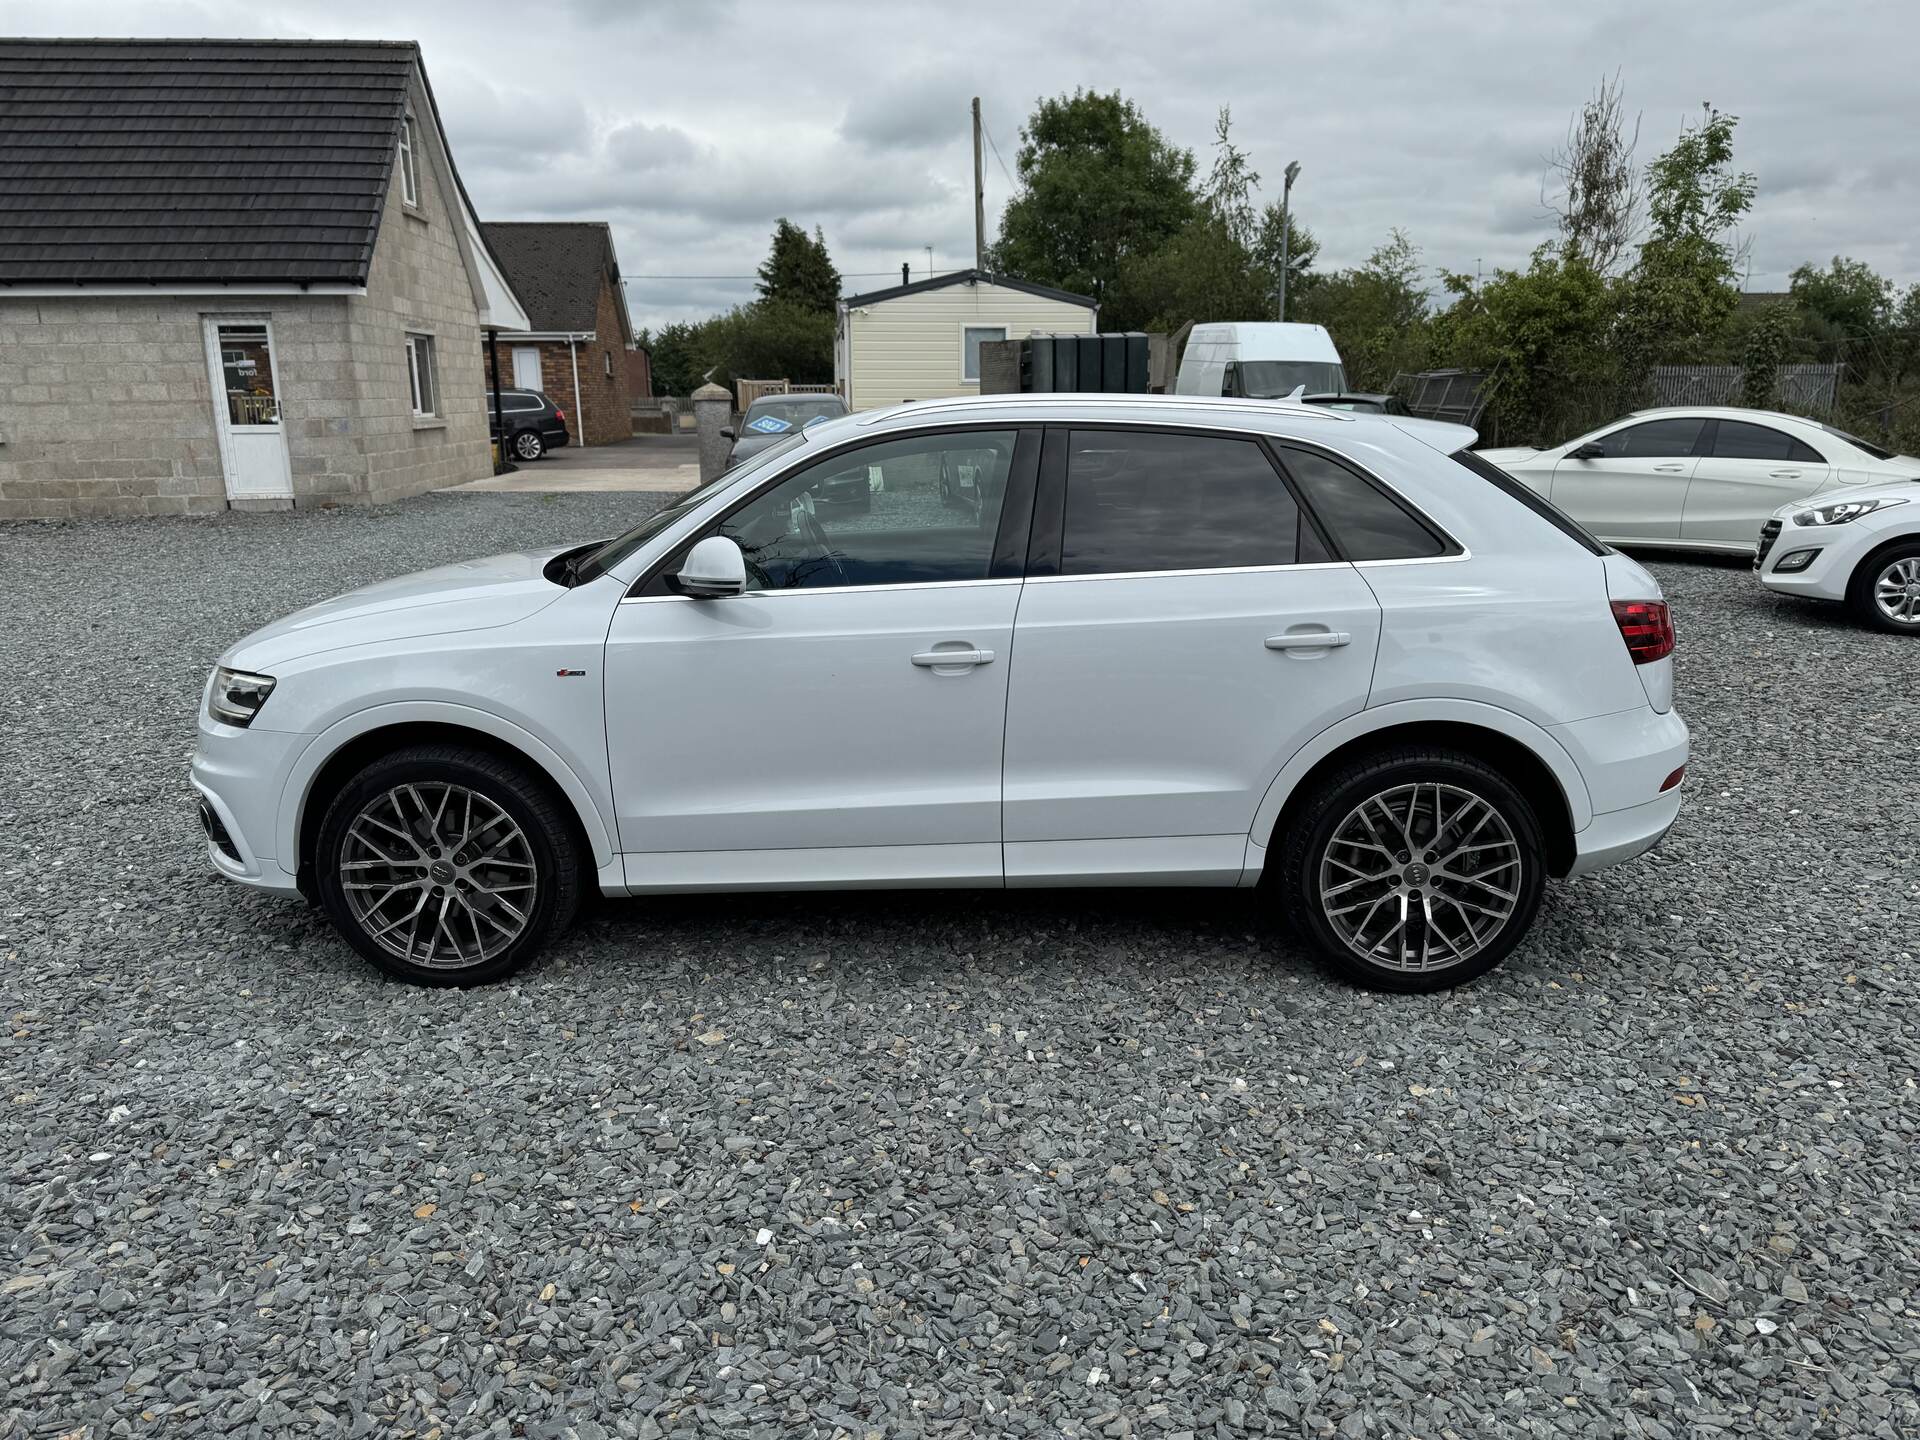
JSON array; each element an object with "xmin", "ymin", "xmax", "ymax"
[{"xmin": 482, "ymin": 221, "xmax": 634, "ymax": 445}]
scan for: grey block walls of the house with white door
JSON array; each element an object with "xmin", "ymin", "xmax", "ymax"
[{"xmin": 0, "ymin": 73, "xmax": 493, "ymax": 520}]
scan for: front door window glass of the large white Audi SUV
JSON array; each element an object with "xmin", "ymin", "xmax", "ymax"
[{"xmin": 716, "ymin": 430, "xmax": 1016, "ymax": 591}]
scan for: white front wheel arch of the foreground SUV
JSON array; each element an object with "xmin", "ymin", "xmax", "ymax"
[{"xmin": 280, "ymin": 703, "xmax": 618, "ymax": 893}]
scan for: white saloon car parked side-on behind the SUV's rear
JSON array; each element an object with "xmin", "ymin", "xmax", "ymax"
[{"xmin": 1480, "ymin": 407, "xmax": 1920, "ymax": 555}]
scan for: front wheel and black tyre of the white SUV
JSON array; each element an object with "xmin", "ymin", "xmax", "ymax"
[{"xmin": 315, "ymin": 745, "xmax": 580, "ymax": 985}]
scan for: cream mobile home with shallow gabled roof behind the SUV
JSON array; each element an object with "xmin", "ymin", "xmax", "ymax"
[{"xmin": 833, "ymin": 265, "xmax": 1100, "ymax": 411}]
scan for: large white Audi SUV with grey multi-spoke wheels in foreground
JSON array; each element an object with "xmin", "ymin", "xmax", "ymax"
[{"xmin": 192, "ymin": 396, "xmax": 1688, "ymax": 991}]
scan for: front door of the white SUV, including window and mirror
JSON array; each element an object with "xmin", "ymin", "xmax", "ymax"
[{"xmin": 607, "ymin": 428, "xmax": 1039, "ymax": 889}]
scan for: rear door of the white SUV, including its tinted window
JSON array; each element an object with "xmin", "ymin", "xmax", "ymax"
[{"xmin": 1004, "ymin": 426, "xmax": 1380, "ymax": 885}]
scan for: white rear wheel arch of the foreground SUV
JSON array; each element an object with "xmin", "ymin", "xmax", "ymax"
[{"xmin": 1242, "ymin": 701, "xmax": 1594, "ymax": 883}]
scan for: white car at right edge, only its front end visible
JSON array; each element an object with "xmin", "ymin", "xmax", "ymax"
[{"xmin": 1753, "ymin": 476, "xmax": 1920, "ymax": 636}]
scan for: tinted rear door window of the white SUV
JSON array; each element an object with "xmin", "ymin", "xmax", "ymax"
[{"xmin": 1060, "ymin": 430, "xmax": 1327, "ymax": 574}]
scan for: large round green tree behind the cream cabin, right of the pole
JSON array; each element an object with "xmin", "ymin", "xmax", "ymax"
[{"xmin": 989, "ymin": 90, "xmax": 1194, "ymax": 311}]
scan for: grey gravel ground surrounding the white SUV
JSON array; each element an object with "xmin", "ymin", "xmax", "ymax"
[{"xmin": 0, "ymin": 495, "xmax": 1920, "ymax": 1440}]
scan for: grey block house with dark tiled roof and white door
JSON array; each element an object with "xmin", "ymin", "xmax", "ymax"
[{"xmin": 0, "ymin": 40, "xmax": 528, "ymax": 518}]
